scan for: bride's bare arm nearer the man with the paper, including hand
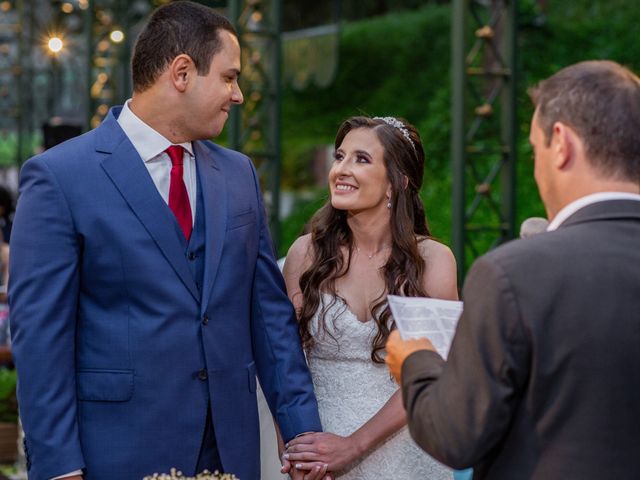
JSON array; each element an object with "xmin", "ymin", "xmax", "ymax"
[{"xmin": 285, "ymin": 240, "xmax": 458, "ymax": 471}]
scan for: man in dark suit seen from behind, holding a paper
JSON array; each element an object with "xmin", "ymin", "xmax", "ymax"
[{"xmin": 387, "ymin": 61, "xmax": 640, "ymax": 480}]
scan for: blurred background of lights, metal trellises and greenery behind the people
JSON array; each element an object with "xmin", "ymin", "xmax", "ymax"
[{"xmin": 0, "ymin": 0, "xmax": 640, "ymax": 478}]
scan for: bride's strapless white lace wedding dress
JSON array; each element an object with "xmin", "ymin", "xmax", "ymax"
[{"xmin": 307, "ymin": 295, "xmax": 452, "ymax": 480}]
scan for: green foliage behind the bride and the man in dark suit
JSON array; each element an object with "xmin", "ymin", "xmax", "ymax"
[{"xmin": 279, "ymin": 0, "xmax": 640, "ymax": 255}]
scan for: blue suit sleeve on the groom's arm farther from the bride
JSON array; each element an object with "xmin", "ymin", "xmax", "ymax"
[{"xmin": 9, "ymin": 157, "xmax": 84, "ymax": 480}]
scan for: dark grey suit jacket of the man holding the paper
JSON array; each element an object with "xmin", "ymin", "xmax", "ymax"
[{"xmin": 402, "ymin": 200, "xmax": 640, "ymax": 480}]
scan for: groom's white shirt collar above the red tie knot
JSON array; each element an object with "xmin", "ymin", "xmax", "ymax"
[{"xmin": 118, "ymin": 99, "xmax": 193, "ymax": 162}]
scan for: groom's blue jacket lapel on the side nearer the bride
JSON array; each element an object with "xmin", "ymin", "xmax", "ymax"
[{"xmin": 193, "ymin": 142, "xmax": 227, "ymax": 308}]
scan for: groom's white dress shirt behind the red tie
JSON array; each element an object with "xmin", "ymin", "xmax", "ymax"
[{"xmin": 51, "ymin": 104, "xmax": 198, "ymax": 480}]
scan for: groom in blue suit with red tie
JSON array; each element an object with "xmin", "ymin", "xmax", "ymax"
[{"xmin": 9, "ymin": 1, "xmax": 321, "ymax": 480}]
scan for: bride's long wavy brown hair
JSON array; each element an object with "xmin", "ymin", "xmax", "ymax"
[{"xmin": 298, "ymin": 116, "xmax": 430, "ymax": 363}]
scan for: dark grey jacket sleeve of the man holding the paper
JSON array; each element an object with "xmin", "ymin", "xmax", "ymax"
[{"xmin": 402, "ymin": 259, "xmax": 529, "ymax": 468}]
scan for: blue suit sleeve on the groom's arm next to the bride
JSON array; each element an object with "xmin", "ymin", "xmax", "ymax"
[{"xmin": 245, "ymin": 158, "xmax": 322, "ymax": 442}]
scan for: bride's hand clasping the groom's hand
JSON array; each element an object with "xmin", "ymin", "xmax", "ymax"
[{"xmin": 283, "ymin": 432, "xmax": 363, "ymax": 472}]
